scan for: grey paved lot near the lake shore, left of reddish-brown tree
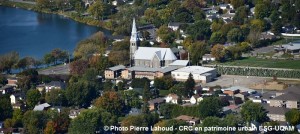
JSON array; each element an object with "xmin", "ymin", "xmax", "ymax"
[{"xmin": 38, "ymin": 64, "xmax": 70, "ymax": 75}]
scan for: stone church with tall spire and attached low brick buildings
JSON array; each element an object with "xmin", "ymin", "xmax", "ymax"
[{"xmin": 105, "ymin": 19, "xmax": 188, "ymax": 80}]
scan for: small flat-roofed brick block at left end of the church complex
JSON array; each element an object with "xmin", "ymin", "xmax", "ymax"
[{"xmin": 104, "ymin": 65, "xmax": 126, "ymax": 79}]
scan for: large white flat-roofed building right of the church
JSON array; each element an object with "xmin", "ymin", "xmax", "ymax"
[{"xmin": 171, "ymin": 66, "xmax": 217, "ymax": 83}]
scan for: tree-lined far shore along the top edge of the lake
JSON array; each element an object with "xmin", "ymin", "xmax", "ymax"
[{"xmin": 0, "ymin": 1, "xmax": 111, "ymax": 30}]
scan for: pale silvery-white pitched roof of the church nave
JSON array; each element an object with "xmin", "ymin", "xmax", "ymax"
[{"xmin": 134, "ymin": 47, "xmax": 177, "ymax": 60}]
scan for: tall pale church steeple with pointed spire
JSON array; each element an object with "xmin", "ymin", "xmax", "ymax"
[{"xmin": 130, "ymin": 18, "xmax": 140, "ymax": 66}]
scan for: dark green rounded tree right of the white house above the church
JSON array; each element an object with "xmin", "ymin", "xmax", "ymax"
[{"xmin": 187, "ymin": 20, "xmax": 211, "ymax": 40}]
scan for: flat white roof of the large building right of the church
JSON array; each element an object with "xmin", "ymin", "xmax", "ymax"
[{"xmin": 173, "ymin": 66, "xmax": 216, "ymax": 74}]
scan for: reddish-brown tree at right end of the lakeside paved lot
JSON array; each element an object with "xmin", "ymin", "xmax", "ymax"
[{"xmin": 70, "ymin": 59, "xmax": 88, "ymax": 75}]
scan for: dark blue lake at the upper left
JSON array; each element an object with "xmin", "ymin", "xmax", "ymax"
[{"xmin": 0, "ymin": 6, "xmax": 109, "ymax": 58}]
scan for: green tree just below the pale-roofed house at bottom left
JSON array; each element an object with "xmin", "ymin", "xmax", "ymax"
[{"xmin": 23, "ymin": 110, "xmax": 48, "ymax": 134}]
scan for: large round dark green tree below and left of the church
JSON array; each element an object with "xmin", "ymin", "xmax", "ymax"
[{"xmin": 66, "ymin": 80, "xmax": 97, "ymax": 107}]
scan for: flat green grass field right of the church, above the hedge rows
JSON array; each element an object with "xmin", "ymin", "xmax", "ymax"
[{"xmin": 212, "ymin": 57, "xmax": 300, "ymax": 69}]
